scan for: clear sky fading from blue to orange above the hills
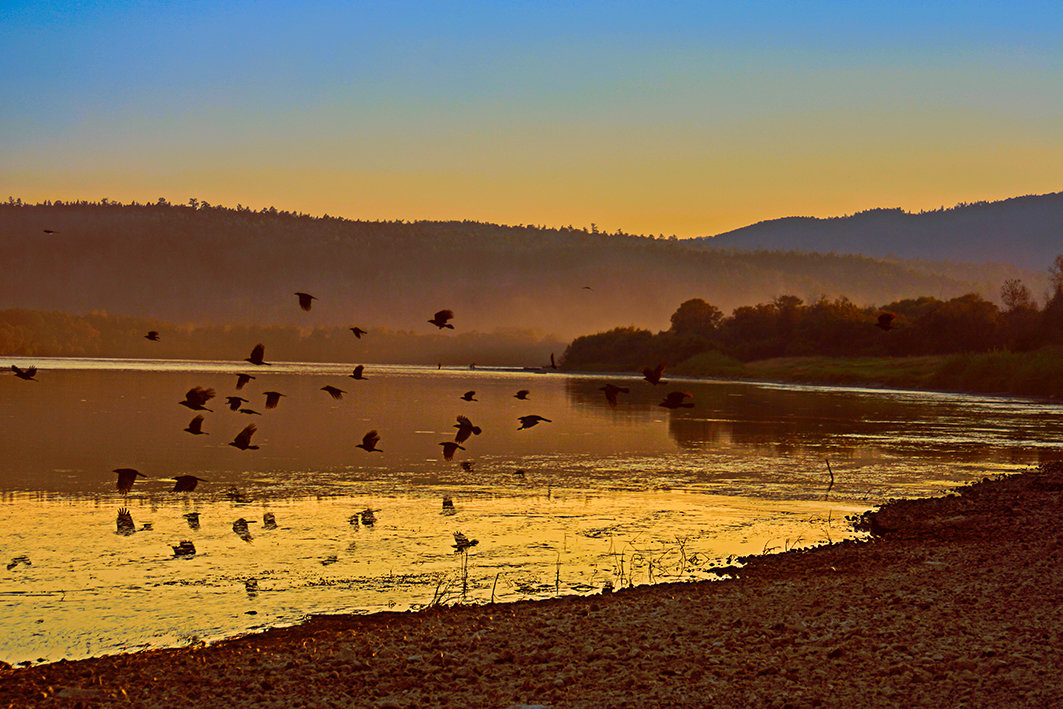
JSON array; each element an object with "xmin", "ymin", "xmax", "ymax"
[{"xmin": 0, "ymin": 0, "xmax": 1063, "ymax": 236}]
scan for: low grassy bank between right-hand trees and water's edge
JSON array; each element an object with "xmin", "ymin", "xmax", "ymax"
[{"xmin": 670, "ymin": 347, "xmax": 1063, "ymax": 398}]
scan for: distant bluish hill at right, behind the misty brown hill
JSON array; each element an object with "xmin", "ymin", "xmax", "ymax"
[{"xmin": 699, "ymin": 192, "xmax": 1063, "ymax": 269}]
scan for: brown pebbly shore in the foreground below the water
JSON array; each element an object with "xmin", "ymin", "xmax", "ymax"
[{"xmin": 0, "ymin": 463, "xmax": 1063, "ymax": 707}]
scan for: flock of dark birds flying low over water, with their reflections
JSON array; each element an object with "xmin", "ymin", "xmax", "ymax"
[{"xmin": 11, "ymin": 291, "xmax": 693, "ymax": 563}]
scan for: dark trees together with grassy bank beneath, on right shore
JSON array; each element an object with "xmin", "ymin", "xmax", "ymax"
[{"xmin": 562, "ymin": 255, "xmax": 1063, "ymax": 396}]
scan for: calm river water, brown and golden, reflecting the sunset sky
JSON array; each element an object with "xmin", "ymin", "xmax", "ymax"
[{"xmin": 0, "ymin": 358, "xmax": 1063, "ymax": 662}]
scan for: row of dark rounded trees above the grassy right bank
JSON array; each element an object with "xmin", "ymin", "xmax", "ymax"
[{"xmin": 562, "ymin": 255, "xmax": 1063, "ymax": 370}]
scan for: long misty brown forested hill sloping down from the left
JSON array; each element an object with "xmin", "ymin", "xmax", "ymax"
[{"xmin": 0, "ymin": 200, "xmax": 1037, "ymax": 337}]
